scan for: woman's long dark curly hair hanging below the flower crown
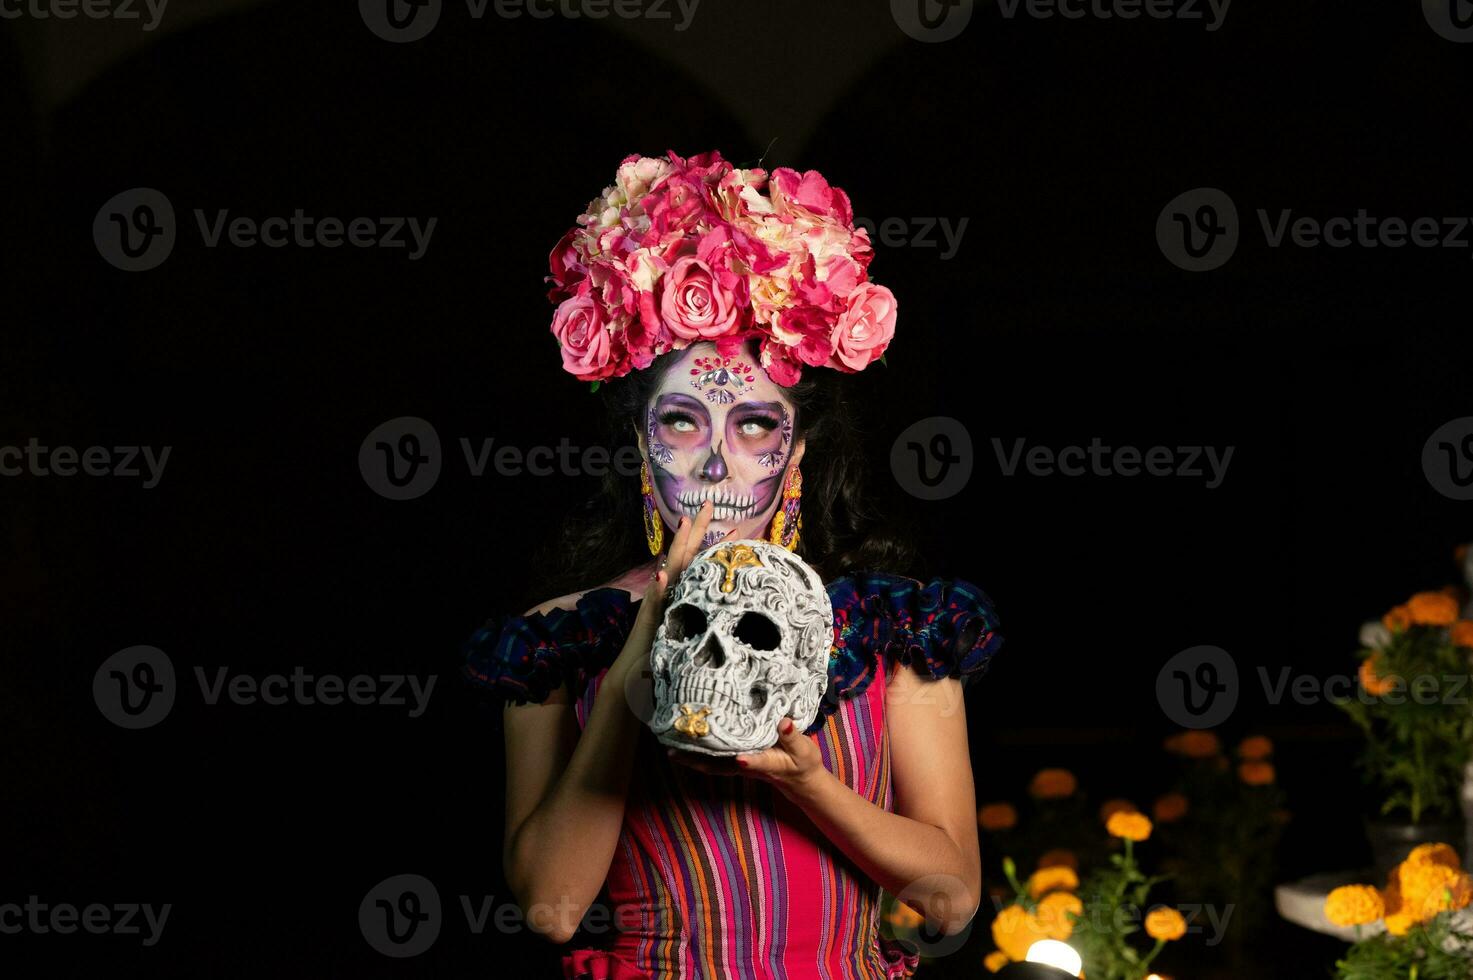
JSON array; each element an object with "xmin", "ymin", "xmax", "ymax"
[{"xmin": 538, "ymin": 340, "xmax": 918, "ymax": 595}]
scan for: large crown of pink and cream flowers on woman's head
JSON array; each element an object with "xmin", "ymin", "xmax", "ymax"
[{"xmin": 548, "ymin": 150, "xmax": 896, "ymax": 386}]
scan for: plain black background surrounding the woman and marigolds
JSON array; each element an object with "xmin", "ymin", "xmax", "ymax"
[{"xmin": 0, "ymin": 0, "xmax": 1473, "ymax": 977}]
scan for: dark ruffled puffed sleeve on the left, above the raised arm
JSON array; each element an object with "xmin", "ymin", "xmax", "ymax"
[{"xmin": 463, "ymin": 588, "xmax": 638, "ymax": 704}]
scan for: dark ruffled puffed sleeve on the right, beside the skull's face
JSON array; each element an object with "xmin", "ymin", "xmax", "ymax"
[{"xmin": 815, "ymin": 572, "xmax": 1003, "ymax": 724}]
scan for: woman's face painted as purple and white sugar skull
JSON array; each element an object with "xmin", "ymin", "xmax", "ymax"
[{"xmin": 639, "ymin": 343, "xmax": 803, "ymax": 547}]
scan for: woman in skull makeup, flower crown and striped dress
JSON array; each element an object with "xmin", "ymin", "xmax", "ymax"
[{"xmin": 467, "ymin": 153, "xmax": 1000, "ymax": 980}]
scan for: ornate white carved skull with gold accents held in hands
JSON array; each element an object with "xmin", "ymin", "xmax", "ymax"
[{"xmin": 650, "ymin": 541, "xmax": 834, "ymax": 756}]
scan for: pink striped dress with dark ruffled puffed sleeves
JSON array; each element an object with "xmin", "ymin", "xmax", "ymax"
[{"xmin": 465, "ymin": 575, "xmax": 1002, "ymax": 980}]
